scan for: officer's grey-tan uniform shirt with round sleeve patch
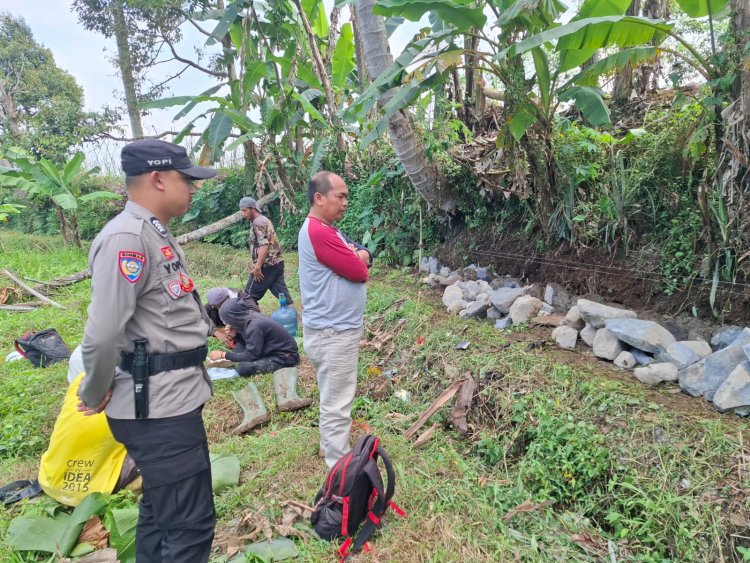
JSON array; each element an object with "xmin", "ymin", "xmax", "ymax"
[{"xmin": 79, "ymin": 201, "xmax": 213, "ymax": 419}]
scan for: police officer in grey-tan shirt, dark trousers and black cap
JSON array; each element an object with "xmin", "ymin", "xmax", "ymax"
[{"xmin": 78, "ymin": 139, "xmax": 216, "ymax": 563}]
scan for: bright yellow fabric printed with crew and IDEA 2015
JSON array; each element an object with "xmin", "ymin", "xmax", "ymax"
[{"xmin": 39, "ymin": 373, "xmax": 127, "ymax": 506}]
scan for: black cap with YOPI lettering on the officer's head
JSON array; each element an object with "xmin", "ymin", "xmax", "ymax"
[{"xmin": 120, "ymin": 139, "xmax": 216, "ymax": 180}]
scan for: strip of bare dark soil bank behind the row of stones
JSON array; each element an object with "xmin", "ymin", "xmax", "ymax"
[{"xmin": 435, "ymin": 229, "xmax": 750, "ymax": 328}]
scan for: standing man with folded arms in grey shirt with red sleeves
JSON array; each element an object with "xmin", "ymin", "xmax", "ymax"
[{"xmin": 298, "ymin": 172, "xmax": 372, "ymax": 467}]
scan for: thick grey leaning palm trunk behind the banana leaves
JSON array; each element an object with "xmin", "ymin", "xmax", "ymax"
[{"xmin": 354, "ymin": 0, "xmax": 456, "ymax": 213}]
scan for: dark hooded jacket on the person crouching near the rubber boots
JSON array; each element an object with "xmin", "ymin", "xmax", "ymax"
[{"xmin": 219, "ymin": 299, "xmax": 299, "ymax": 365}]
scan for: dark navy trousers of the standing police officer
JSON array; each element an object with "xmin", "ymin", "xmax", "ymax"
[{"xmin": 107, "ymin": 407, "xmax": 216, "ymax": 563}]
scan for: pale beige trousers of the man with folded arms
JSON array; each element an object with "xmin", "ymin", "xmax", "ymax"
[{"xmin": 303, "ymin": 327, "xmax": 363, "ymax": 468}]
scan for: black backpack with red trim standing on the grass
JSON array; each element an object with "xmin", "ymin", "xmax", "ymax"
[{"xmin": 311, "ymin": 434, "xmax": 404, "ymax": 560}]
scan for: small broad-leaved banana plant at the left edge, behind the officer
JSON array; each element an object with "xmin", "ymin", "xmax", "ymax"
[{"xmin": 0, "ymin": 147, "xmax": 121, "ymax": 248}]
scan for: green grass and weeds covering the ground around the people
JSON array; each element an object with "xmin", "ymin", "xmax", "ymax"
[{"xmin": 0, "ymin": 233, "xmax": 750, "ymax": 561}]
